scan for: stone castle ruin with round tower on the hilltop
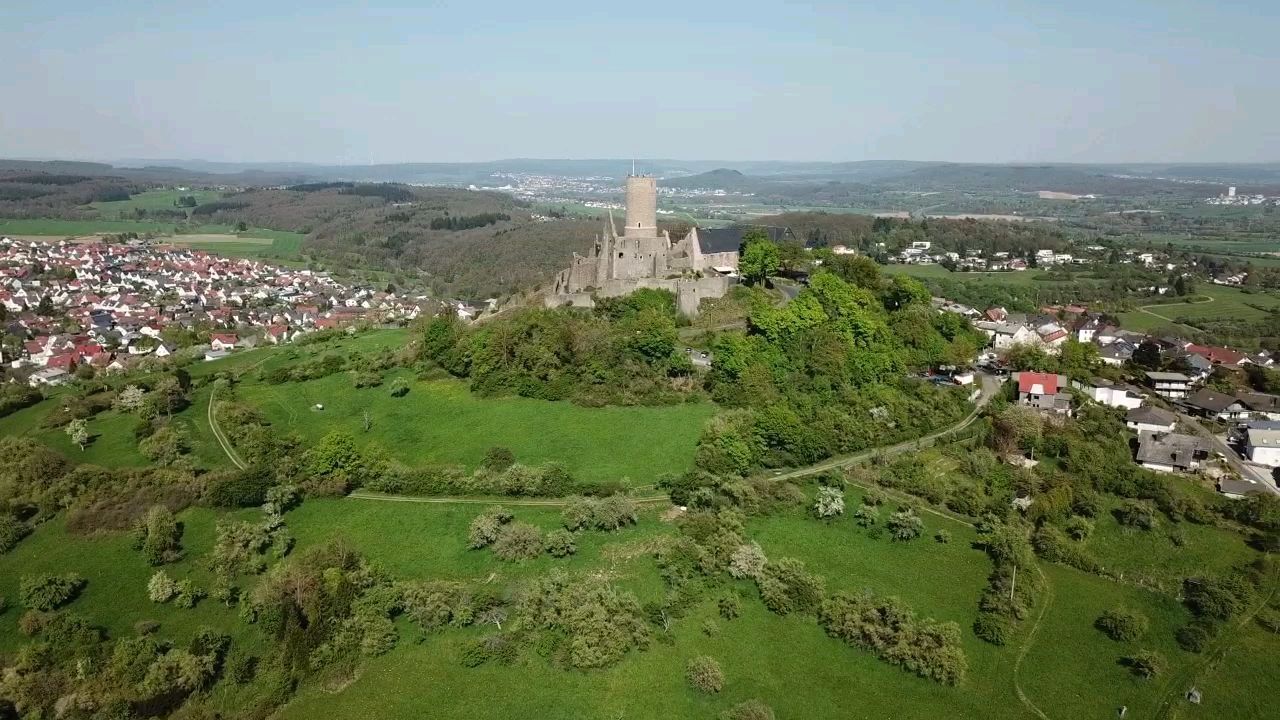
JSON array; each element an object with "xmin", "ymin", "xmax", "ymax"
[{"xmin": 545, "ymin": 174, "xmax": 737, "ymax": 315}]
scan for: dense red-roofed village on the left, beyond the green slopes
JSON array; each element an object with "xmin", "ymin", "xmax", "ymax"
[{"xmin": 0, "ymin": 237, "xmax": 479, "ymax": 386}]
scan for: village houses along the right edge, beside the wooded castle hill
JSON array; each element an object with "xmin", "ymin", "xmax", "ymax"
[{"xmin": 933, "ymin": 297, "xmax": 1280, "ymax": 498}]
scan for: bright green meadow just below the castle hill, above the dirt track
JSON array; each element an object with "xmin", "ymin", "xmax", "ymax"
[{"xmin": 244, "ymin": 372, "xmax": 716, "ymax": 484}]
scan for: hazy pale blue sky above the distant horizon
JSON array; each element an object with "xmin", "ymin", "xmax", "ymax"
[{"xmin": 0, "ymin": 0, "xmax": 1280, "ymax": 163}]
